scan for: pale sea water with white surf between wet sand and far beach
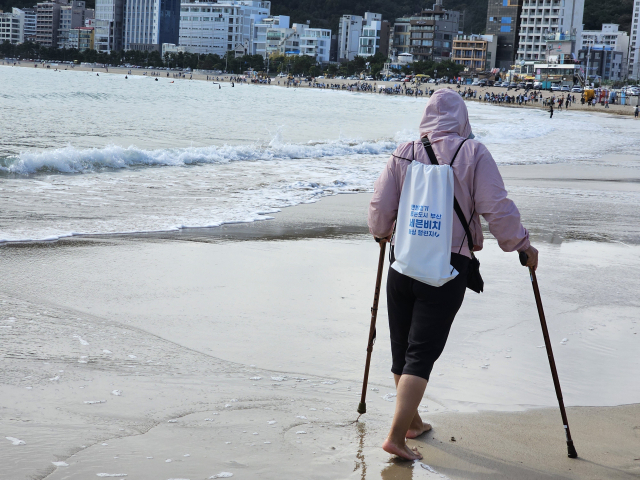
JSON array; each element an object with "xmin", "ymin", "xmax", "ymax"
[{"xmin": 0, "ymin": 66, "xmax": 640, "ymax": 242}]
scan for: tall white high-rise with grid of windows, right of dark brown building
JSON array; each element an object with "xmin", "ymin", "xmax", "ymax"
[{"xmin": 516, "ymin": 0, "xmax": 584, "ymax": 62}]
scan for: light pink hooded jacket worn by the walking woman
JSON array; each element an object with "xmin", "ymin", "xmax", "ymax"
[{"xmin": 369, "ymin": 89, "xmax": 530, "ymax": 257}]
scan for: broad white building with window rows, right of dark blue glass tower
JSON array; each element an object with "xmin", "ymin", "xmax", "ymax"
[{"xmin": 179, "ymin": 0, "xmax": 271, "ymax": 56}]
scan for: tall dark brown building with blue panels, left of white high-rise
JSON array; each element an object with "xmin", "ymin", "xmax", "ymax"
[{"xmin": 486, "ymin": 0, "xmax": 523, "ymax": 71}]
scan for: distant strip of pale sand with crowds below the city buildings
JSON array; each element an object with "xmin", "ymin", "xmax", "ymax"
[{"xmin": 6, "ymin": 61, "xmax": 640, "ymax": 117}]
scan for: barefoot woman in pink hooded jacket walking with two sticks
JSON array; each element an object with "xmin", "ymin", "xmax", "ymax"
[{"xmin": 369, "ymin": 90, "xmax": 538, "ymax": 460}]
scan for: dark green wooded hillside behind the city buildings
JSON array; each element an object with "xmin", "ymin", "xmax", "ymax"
[{"xmin": 0, "ymin": 0, "xmax": 633, "ymax": 33}]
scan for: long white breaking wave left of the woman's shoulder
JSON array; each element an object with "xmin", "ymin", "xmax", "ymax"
[{"xmin": 0, "ymin": 140, "xmax": 397, "ymax": 175}]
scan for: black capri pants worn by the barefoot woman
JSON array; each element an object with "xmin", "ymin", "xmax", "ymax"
[{"xmin": 387, "ymin": 253, "xmax": 470, "ymax": 380}]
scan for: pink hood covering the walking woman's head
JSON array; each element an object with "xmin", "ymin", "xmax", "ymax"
[{"xmin": 420, "ymin": 88, "xmax": 471, "ymax": 141}]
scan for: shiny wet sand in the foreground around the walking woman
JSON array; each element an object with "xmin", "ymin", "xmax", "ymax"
[{"xmin": 0, "ymin": 157, "xmax": 640, "ymax": 480}]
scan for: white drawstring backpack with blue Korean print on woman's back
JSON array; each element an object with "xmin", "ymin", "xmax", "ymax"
[{"xmin": 391, "ymin": 142, "xmax": 464, "ymax": 287}]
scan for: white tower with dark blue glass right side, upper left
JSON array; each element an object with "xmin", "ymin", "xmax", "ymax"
[{"xmin": 123, "ymin": 0, "xmax": 180, "ymax": 52}]
